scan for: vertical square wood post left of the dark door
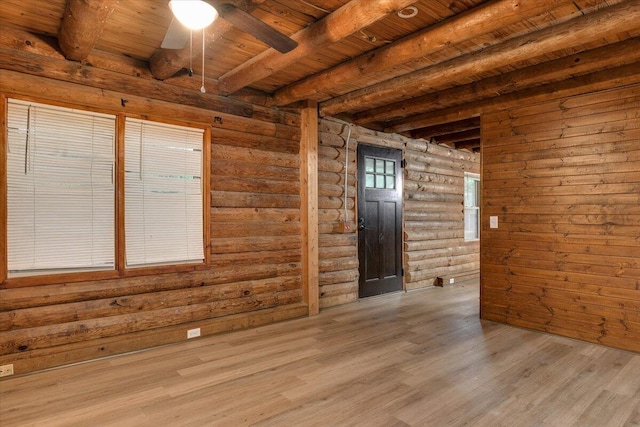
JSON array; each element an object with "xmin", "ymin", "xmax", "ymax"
[{"xmin": 300, "ymin": 101, "xmax": 320, "ymax": 316}]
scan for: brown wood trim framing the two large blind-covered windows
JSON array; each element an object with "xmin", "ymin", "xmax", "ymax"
[{"xmin": 0, "ymin": 93, "xmax": 211, "ymax": 289}]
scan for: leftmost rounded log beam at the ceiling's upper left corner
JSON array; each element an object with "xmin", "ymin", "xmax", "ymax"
[{"xmin": 58, "ymin": 0, "xmax": 120, "ymax": 61}]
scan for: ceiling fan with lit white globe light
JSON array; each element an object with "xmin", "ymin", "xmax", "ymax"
[{"xmin": 161, "ymin": 0, "xmax": 298, "ymax": 53}]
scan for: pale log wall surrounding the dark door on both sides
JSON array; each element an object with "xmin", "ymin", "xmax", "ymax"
[{"xmin": 318, "ymin": 119, "xmax": 480, "ymax": 307}]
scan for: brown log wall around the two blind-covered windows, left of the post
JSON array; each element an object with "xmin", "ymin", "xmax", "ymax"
[{"xmin": 0, "ymin": 70, "xmax": 307, "ymax": 374}]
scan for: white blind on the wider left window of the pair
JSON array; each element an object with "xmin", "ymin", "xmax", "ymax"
[{"xmin": 7, "ymin": 100, "xmax": 115, "ymax": 277}]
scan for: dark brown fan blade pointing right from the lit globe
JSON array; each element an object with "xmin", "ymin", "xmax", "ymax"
[{"xmin": 216, "ymin": 3, "xmax": 298, "ymax": 53}]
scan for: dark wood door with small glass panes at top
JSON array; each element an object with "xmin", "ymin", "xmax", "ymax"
[{"xmin": 358, "ymin": 145, "xmax": 402, "ymax": 297}]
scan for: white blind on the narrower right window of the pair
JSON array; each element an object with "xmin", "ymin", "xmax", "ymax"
[{"xmin": 125, "ymin": 118, "xmax": 204, "ymax": 266}]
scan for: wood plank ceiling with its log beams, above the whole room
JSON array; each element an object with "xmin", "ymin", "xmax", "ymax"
[{"xmin": 0, "ymin": 0, "xmax": 640, "ymax": 150}]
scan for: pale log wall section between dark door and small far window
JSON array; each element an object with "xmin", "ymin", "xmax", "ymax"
[{"xmin": 403, "ymin": 140, "xmax": 480, "ymax": 289}]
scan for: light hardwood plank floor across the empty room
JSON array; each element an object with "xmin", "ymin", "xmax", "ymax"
[{"xmin": 0, "ymin": 282, "xmax": 640, "ymax": 427}]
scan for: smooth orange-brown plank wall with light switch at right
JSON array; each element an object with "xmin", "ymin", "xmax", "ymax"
[{"xmin": 481, "ymin": 84, "xmax": 640, "ymax": 351}]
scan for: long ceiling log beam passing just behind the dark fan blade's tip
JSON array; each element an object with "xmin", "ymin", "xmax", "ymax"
[{"xmin": 218, "ymin": 0, "xmax": 417, "ymax": 94}]
